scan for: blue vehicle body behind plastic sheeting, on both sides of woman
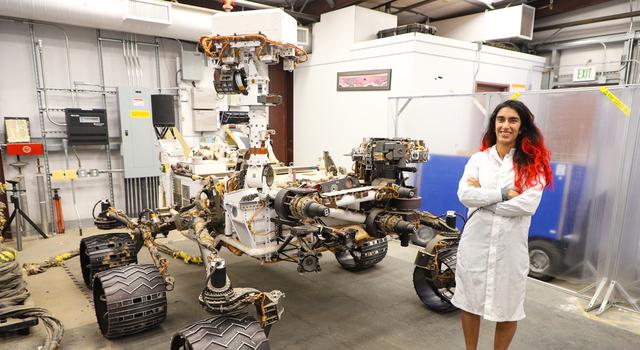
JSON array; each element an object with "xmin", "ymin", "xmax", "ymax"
[{"xmin": 418, "ymin": 154, "xmax": 582, "ymax": 240}]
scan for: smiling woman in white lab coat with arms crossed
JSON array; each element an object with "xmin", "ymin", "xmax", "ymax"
[{"xmin": 451, "ymin": 100, "xmax": 552, "ymax": 350}]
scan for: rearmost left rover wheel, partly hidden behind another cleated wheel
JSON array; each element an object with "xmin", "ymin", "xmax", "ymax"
[{"xmin": 80, "ymin": 232, "xmax": 138, "ymax": 288}]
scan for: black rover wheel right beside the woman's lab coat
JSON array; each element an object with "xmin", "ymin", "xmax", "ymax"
[{"xmin": 413, "ymin": 266, "xmax": 457, "ymax": 313}]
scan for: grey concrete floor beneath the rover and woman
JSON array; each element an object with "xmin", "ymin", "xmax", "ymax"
[{"xmin": 0, "ymin": 229, "xmax": 640, "ymax": 350}]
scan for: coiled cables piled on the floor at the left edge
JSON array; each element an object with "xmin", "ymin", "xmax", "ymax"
[{"xmin": 0, "ymin": 245, "xmax": 64, "ymax": 350}]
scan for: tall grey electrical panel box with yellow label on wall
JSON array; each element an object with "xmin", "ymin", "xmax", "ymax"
[{"xmin": 118, "ymin": 86, "xmax": 160, "ymax": 179}]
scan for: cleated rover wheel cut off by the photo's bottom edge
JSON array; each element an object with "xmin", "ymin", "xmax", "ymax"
[{"xmin": 171, "ymin": 313, "xmax": 271, "ymax": 350}]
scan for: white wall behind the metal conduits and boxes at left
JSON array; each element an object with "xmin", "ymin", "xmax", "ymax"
[{"xmin": 0, "ymin": 21, "xmax": 201, "ymax": 230}]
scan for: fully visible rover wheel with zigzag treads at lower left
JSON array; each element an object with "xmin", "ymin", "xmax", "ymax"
[{"xmin": 93, "ymin": 264, "xmax": 167, "ymax": 338}]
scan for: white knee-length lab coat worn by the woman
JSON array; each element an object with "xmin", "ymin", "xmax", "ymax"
[{"xmin": 451, "ymin": 146, "xmax": 544, "ymax": 322}]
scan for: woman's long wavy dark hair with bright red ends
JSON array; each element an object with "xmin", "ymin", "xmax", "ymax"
[{"xmin": 480, "ymin": 100, "xmax": 553, "ymax": 192}]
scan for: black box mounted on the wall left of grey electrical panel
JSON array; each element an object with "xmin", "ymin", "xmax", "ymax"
[{"xmin": 64, "ymin": 108, "xmax": 109, "ymax": 146}]
